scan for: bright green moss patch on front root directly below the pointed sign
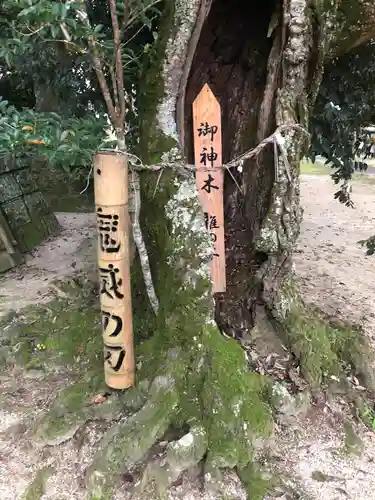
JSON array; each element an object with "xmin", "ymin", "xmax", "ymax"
[{"xmin": 201, "ymin": 329, "xmax": 272, "ymax": 467}]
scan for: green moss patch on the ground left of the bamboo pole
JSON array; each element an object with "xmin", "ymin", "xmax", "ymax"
[{"xmin": 0, "ymin": 283, "xmax": 103, "ymax": 373}]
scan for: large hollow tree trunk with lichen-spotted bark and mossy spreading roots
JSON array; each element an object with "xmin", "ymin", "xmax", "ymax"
[{"xmin": 81, "ymin": 0, "xmax": 373, "ymax": 498}]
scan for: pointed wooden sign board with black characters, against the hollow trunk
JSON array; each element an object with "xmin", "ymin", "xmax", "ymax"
[{"xmin": 193, "ymin": 84, "xmax": 226, "ymax": 293}]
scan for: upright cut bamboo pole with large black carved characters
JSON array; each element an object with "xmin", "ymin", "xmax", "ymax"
[{"xmin": 94, "ymin": 152, "xmax": 135, "ymax": 389}]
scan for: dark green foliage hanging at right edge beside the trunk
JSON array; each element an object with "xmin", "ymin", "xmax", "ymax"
[{"xmin": 310, "ymin": 42, "xmax": 375, "ymax": 206}]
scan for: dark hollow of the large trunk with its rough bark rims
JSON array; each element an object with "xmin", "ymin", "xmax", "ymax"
[{"xmin": 153, "ymin": 0, "xmax": 323, "ymax": 338}]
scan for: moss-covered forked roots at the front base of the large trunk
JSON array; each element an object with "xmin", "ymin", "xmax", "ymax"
[{"xmin": 86, "ymin": 327, "xmax": 272, "ymax": 500}]
